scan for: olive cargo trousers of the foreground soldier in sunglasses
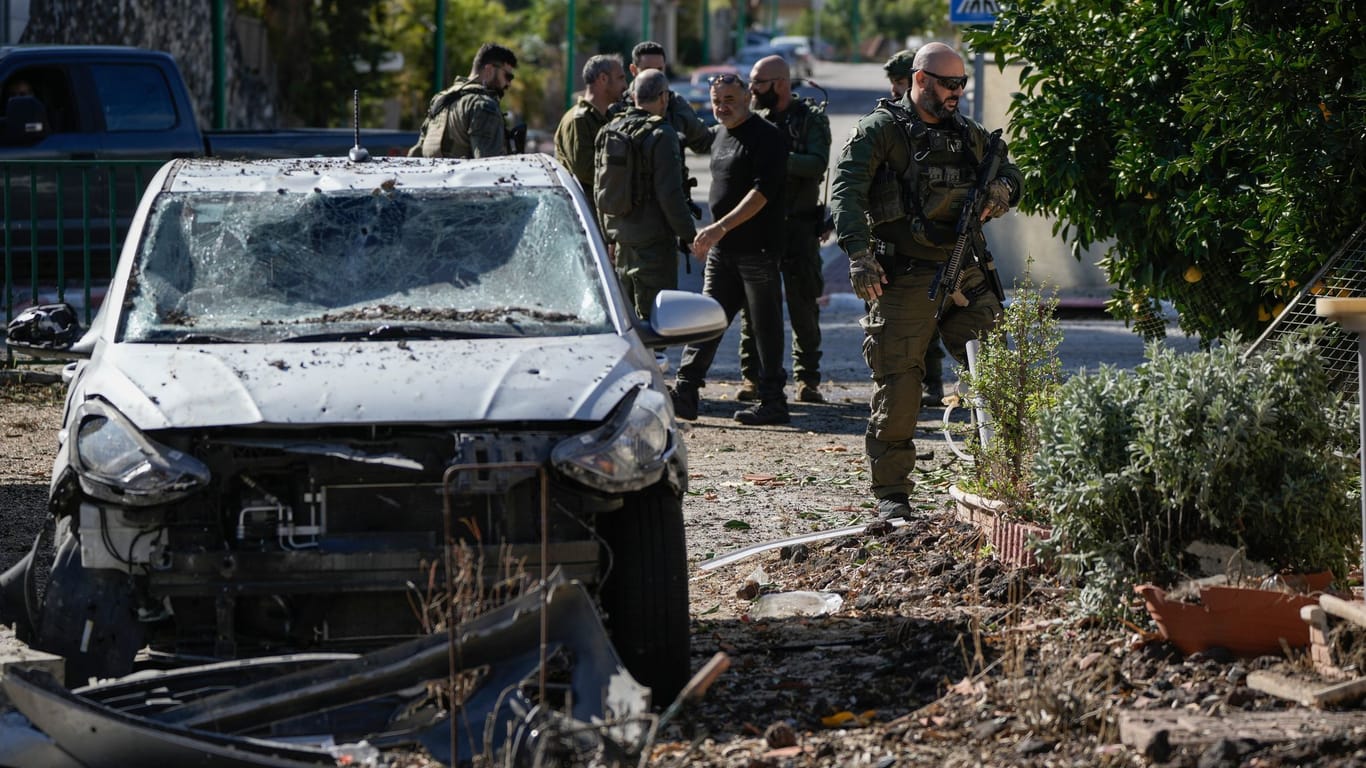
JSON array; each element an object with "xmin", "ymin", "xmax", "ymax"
[{"xmin": 861, "ymin": 261, "xmax": 1001, "ymax": 499}]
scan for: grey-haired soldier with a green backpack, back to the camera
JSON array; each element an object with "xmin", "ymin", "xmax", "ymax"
[{"xmin": 594, "ymin": 70, "xmax": 697, "ymax": 318}]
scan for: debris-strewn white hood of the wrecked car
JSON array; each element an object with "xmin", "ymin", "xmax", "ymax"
[{"xmin": 76, "ymin": 335, "xmax": 654, "ymax": 429}]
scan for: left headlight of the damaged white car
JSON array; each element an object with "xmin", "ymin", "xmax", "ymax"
[{"xmin": 71, "ymin": 400, "xmax": 209, "ymax": 506}]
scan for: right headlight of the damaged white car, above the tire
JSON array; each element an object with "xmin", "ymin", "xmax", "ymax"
[{"xmin": 550, "ymin": 387, "xmax": 673, "ymax": 493}]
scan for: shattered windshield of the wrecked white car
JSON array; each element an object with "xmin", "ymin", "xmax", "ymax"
[{"xmin": 120, "ymin": 187, "xmax": 613, "ymax": 342}]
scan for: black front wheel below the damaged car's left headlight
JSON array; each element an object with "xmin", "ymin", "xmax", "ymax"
[{"xmin": 34, "ymin": 518, "xmax": 143, "ymax": 687}]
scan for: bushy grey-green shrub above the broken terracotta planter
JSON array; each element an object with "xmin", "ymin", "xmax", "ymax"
[{"xmin": 1033, "ymin": 327, "xmax": 1361, "ymax": 605}]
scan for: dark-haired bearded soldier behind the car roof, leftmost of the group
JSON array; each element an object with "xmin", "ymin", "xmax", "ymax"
[{"xmin": 408, "ymin": 42, "xmax": 516, "ymax": 157}]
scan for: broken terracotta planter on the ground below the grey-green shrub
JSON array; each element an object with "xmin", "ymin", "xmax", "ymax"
[{"xmin": 1134, "ymin": 584, "xmax": 1318, "ymax": 656}]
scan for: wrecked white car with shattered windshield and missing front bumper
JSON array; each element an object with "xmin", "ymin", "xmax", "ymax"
[{"xmin": 0, "ymin": 156, "xmax": 725, "ymax": 702}]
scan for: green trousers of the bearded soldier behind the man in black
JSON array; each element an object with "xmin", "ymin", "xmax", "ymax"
[{"xmin": 740, "ymin": 221, "xmax": 825, "ymax": 387}]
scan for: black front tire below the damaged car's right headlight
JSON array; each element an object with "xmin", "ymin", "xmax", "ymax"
[{"xmin": 600, "ymin": 485, "xmax": 691, "ymax": 707}]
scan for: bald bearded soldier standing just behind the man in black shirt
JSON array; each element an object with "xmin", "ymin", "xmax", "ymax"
[{"xmin": 738, "ymin": 56, "xmax": 831, "ymax": 403}]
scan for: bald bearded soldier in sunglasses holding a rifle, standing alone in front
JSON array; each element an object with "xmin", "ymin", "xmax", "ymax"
[{"xmin": 831, "ymin": 42, "xmax": 1023, "ymax": 519}]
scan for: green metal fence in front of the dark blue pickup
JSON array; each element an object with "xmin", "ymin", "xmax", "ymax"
[{"xmin": 0, "ymin": 160, "xmax": 164, "ymax": 365}]
